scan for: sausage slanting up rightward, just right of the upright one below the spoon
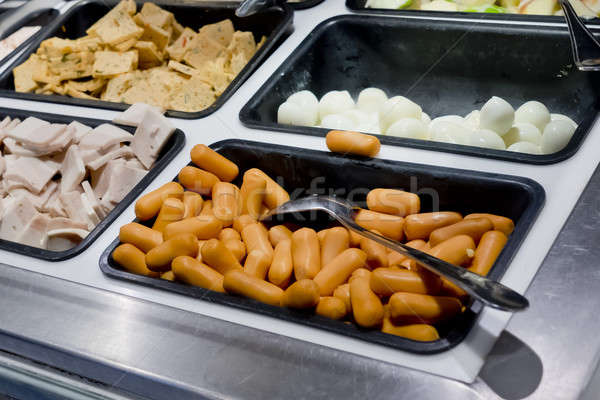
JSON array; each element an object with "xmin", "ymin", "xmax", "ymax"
[{"xmin": 314, "ymin": 248, "xmax": 367, "ymax": 296}]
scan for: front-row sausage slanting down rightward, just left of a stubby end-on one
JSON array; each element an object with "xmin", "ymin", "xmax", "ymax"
[{"xmin": 223, "ymin": 269, "xmax": 283, "ymax": 306}]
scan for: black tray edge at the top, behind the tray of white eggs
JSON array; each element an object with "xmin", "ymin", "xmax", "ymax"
[{"xmin": 346, "ymin": 0, "xmax": 598, "ymax": 24}]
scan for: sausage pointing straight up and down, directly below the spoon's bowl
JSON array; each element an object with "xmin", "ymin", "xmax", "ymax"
[{"xmin": 292, "ymin": 228, "xmax": 321, "ymax": 280}]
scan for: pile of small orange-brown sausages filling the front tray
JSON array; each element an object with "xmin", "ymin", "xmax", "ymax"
[{"xmin": 112, "ymin": 139, "xmax": 514, "ymax": 341}]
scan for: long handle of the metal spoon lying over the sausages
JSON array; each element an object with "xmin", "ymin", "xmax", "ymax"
[{"xmin": 338, "ymin": 215, "xmax": 529, "ymax": 311}]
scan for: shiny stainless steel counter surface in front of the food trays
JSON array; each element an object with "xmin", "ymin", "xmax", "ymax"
[{"xmin": 0, "ymin": 161, "xmax": 600, "ymax": 400}]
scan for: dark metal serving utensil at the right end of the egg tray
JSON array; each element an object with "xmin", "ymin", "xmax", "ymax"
[{"xmin": 558, "ymin": 0, "xmax": 600, "ymax": 71}]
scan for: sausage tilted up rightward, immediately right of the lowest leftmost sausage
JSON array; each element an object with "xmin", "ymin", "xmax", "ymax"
[{"xmin": 146, "ymin": 233, "xmax": 198, "ymax": 272}]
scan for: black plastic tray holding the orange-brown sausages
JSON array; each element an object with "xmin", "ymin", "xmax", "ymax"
[{"xmin": 100, "ymin": 140, "xmax": 545, "ymax": 354}]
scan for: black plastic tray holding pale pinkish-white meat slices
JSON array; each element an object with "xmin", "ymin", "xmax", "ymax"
[{"xmin": 0, "ymin": 108, "xmax": 185, "ymax": 261}]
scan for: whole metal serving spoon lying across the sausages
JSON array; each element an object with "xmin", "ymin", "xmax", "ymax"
[{"xmin": 261, "ymin": 196, "xmax": 529, "ymax": 311}]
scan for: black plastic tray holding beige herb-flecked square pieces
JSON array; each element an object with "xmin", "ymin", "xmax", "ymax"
[{"xmin": 0, "ymin": 0, "xmax": 293, "ymax": 119}]
